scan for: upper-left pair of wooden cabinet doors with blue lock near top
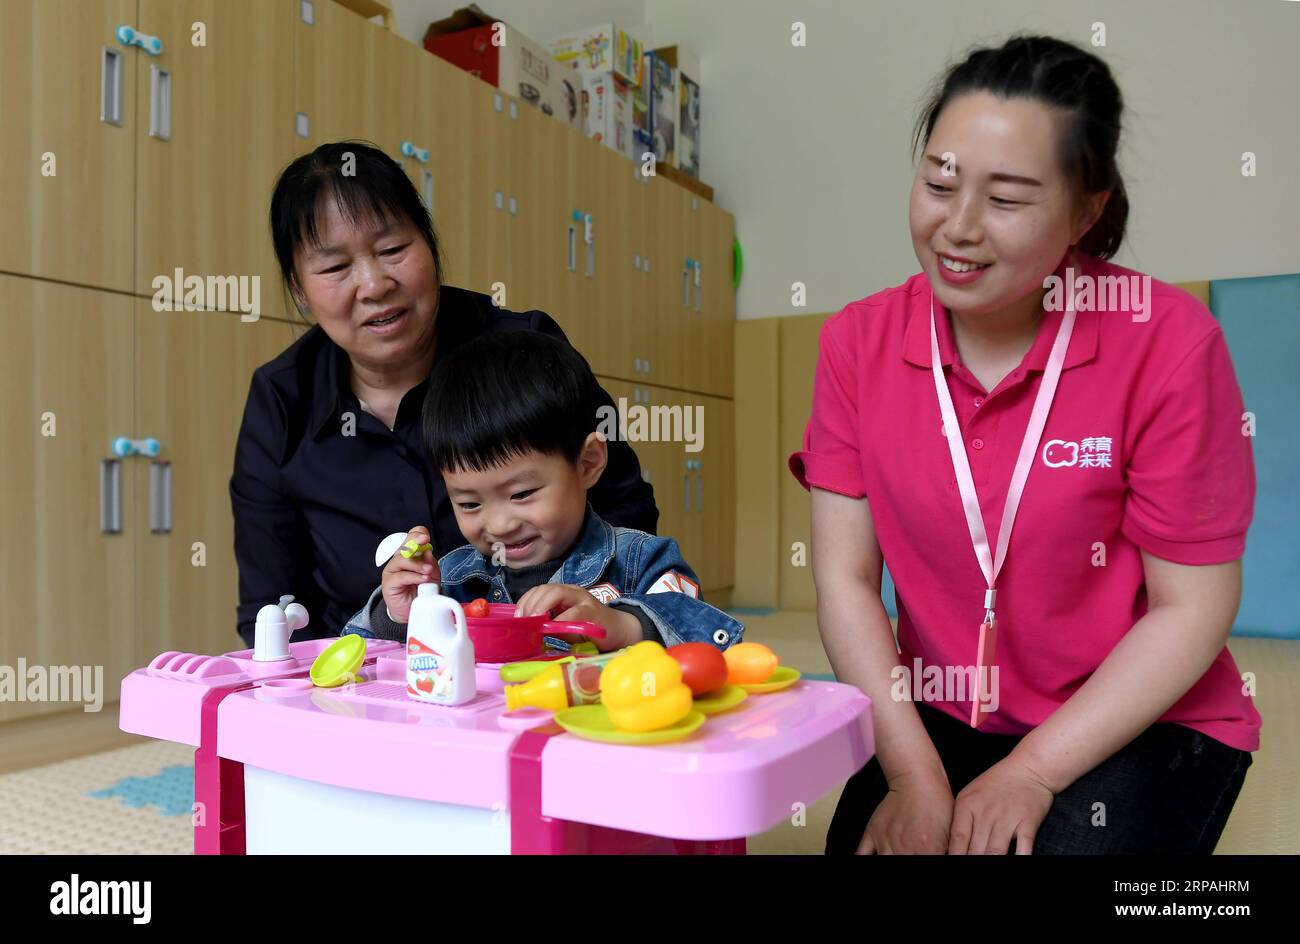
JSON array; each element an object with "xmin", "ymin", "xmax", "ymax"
[{"xmin": 0, "ymin": 0, "xmax": 297, "ymax": 315}]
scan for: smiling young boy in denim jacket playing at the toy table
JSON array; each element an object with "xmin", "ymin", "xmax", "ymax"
[{"xmin": 343, "ymin": 332, "xmax": 744, "ymax": 651}]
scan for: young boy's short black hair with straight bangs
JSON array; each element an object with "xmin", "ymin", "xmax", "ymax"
[{"xmin": 423, "ymin": 330, "xmax": 599, "ymax": 481}]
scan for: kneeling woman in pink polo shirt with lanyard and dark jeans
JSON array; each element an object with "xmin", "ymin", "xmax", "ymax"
[{"xmin": 790, "ymin": 36, "xmax": 1260, "ymax": 853}]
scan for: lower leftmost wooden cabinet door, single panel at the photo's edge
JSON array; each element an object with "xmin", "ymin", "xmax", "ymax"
[{"xmin": 0, "ymin": 274, "xmax": 140, "ymax": 720}]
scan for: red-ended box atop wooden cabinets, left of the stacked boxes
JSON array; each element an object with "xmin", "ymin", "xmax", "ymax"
[{"xmin": 424, "ymin": 4, "xmax": 581, "ymax": 127}]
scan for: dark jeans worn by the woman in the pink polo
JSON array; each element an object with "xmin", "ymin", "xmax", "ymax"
[{"xmin": 826, "ymin": 702, "xmax": 1251, "ymax": 856}]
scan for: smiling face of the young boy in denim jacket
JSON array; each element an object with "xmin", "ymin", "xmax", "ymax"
[{"xmin": 442, "ymin": 433, "xmax": 608, "ymax": 570}]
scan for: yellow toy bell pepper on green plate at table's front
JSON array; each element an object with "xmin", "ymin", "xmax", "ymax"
[{"xmin": 601, "ymin": 640, "xmax": 692, "ymax": 731}]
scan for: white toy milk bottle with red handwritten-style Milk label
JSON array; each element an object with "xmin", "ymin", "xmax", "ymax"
[{"xmin": 407, "ymin": 584, "xmax": 476, "ymax": 705}]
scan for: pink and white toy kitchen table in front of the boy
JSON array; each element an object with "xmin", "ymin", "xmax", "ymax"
[{"xmin": 120, "ymin": 640, "xmax": 874, "ymax": 853}]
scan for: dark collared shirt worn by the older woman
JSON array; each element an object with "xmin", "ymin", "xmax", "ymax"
[{"xmin": 230, "ymin": 285, "xmax": 659, "ymax": 645}]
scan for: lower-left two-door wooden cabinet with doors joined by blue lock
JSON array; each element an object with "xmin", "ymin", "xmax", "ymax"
[{"xmin": 0, "ymin": 276, "xmax": 303, "ymax": 720}]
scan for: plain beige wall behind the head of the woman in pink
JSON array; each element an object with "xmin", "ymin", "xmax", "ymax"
[{"xmin": 645, "ymin": 0, "xmax": 1300, "ymax": 319}]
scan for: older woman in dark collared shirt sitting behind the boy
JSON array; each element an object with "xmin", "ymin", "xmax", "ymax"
[{"xmin": 230, "ymin": 142, "xmax": 659, "ymax": 645}]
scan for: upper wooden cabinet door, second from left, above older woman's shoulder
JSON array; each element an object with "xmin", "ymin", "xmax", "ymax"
[{"xmin": 137, "ymin": 0, "xmax": 299, "ymax": 316}]
